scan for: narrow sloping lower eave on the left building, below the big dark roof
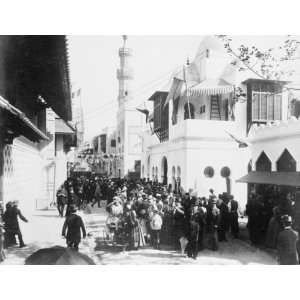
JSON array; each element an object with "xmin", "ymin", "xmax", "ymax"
[{"xmin": 0, "ymin": 96, "xmax": 49, "ymax": 142}]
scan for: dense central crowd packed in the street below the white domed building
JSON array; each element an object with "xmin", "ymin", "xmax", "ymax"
[{"xmin": 57, "ymin": 176, "xmax": 240, "ymax": 259}]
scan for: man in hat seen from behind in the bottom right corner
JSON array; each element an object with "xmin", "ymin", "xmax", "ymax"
[{"xmin": 277, "ymin": 215, "xmax": 298, "ymax": 265}]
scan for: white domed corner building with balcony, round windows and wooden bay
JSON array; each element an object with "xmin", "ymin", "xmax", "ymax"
[{"xmin": 142, "ymin": 37, "xmax": 287, "ymax": 209}]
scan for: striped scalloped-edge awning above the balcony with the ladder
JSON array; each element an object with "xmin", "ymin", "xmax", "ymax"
[{"xmin": 189, "ymin": 79, "xmax": 234, "ymax": 96}]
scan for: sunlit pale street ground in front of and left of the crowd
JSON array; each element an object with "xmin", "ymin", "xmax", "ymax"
[{"xmin": 2, "ymin": 208, "xmax": 277, "ymax": 265}]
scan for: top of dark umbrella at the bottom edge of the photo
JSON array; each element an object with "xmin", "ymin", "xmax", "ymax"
[{"xmin": 25, "ymin": 246, "xmax": 95, "ymax": 265}]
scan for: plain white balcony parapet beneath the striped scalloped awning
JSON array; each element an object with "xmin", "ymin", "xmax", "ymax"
[{"xmin": 170, "ymin": 119, "xmax": 236, "ymax": 140}]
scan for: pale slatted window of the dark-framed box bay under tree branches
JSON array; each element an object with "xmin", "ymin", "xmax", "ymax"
[{"xmin": 252, "ymin": 91, "xmax": 282, "ymax": 121}]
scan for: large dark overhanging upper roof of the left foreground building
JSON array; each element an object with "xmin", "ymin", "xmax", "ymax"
[{"xmin": 0, "ymin": 35, "xmax": 72, "ymax": 121}]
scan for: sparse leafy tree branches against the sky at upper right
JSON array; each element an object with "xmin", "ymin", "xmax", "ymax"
[{"xmin": 217, "ymin": 35, "xmax": 300, "ymax": 80}]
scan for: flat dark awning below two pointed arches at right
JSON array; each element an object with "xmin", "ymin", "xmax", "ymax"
[{"xmin": 236, "ymin": 171, "xmax": 300, "ymax": 187}]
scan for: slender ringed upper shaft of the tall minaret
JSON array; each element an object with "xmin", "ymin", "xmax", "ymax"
[{"xmin": 117, "ymin": 35, "xmax": 133, "ymax": 106}]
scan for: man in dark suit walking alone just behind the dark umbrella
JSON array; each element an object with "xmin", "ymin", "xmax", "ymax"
[{"xmin": 62, "ymin": 205, "xmax": 86, "ymax": 251}]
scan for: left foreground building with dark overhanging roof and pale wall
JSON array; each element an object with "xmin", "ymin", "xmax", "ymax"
[{"xmin": 0, "ymin": 36, "xmax": 72, "ymax": 211}]
